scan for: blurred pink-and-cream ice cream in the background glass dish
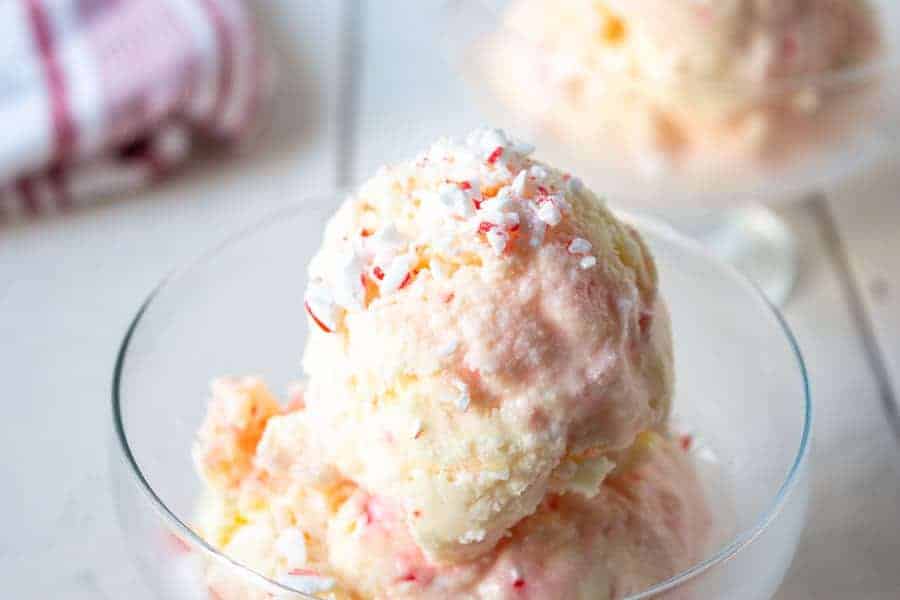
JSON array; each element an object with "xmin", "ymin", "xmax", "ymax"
[{"xmin": 492, "ymin": 0, "xmax": 878, "ymax": 168}]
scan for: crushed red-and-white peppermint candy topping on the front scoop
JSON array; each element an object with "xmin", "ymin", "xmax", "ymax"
[{"xmin": 304, "ymin": 129, "xmax": 597, "ymax": 328}]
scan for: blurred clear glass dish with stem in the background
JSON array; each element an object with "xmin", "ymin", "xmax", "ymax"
[{"xmin": 444, "ymin": 0, "xmax": 900, "ymax": 303}]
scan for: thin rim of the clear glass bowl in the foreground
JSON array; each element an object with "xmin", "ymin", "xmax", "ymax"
[{"xmin": 111, "ymin": 199, "xmax": 813, "ymax": 600}]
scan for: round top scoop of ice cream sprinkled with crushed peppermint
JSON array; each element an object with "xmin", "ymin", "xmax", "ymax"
[{"xmin": 304, "ymin": 130, "xmax": 672, "ymax": 563}]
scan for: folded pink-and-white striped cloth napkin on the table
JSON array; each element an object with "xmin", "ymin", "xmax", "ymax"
[{"xmin": 0, "ymin": 0, "xmax": 268, "ymax": 220}]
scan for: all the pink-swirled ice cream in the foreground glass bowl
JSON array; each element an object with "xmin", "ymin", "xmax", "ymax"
[{"xmin": 195, "ymin": 130, "xmax": 710, "ymax": 599}]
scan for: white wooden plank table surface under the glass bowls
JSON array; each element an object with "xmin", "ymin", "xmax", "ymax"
[{"xmin": 0, "ymin": 0, "xmax": 900, "ymax": 600}]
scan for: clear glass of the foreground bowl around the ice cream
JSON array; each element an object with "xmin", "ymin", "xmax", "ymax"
[{"xmin": 110, "ymin": 196, "xmax": 811, "ymax": 600}]
